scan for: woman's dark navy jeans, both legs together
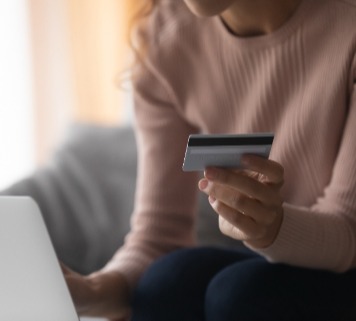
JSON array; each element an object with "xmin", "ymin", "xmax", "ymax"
[{"xmin": 132, "ymin": 248, "xmax": 356, "ymax": 321}]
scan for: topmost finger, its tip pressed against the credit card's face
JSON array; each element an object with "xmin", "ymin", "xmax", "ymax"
[{"xmin": 241, "ymin": 154, "xmax": 284, "ymax": 185}]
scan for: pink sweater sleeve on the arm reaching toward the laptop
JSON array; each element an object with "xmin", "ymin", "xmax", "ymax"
[{"xmin": 105, "ymin": 51, "xmax": 198, "ymax": 288}]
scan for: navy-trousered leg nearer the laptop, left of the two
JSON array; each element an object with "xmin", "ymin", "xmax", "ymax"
[{"xmin": 132, "ymin": 248, "xmax": 255, "ymax": 321}]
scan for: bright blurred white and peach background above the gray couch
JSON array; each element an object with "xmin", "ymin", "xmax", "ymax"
[{"xmin": 0, "ymin": 0, "xmax": 137, "ymax": 188}]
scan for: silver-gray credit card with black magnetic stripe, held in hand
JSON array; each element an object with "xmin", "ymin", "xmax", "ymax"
[{"xmin": 182, "ymin": 133, "xmax": 274, "ymax": 172}]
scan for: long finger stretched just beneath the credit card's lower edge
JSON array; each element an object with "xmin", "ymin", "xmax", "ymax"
[{"xmin": 204, "ymin": 168, "xmax": 282, "ymax": 207}]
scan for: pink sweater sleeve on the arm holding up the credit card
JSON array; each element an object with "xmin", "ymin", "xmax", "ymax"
[{"xmin": 250, "ymin": 53, "xmax": 356, "ymax": 272}]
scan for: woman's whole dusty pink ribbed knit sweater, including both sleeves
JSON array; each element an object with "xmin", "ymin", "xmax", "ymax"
[{"xmin": 106, "ymin": 0, "xmax": 356, "ymax": 286}]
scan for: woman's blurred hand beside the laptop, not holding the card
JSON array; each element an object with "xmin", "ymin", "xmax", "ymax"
[{"xmin": 61, "ymin": 264, "xmax": 130, "ymax": 321}]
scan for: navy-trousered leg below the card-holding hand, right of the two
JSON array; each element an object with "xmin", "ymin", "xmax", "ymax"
[{"xmin": 205, "ymin": 258, "xmax": 356, "ymax": 321}]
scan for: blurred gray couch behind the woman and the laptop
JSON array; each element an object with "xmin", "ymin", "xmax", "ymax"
[{"xmin": 0, "ymin": 124, "xmax": 241, "ymax": 274}]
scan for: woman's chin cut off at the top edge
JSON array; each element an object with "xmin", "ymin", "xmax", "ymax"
[{"xmin": 184, "ymin": 0, "xmax": 234, "ymax": 17}]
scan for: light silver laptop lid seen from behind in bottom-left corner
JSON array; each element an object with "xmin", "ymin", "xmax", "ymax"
[{"xmin": 0, "ymin": 196, "xmax": 79, "ymax": 321}]
